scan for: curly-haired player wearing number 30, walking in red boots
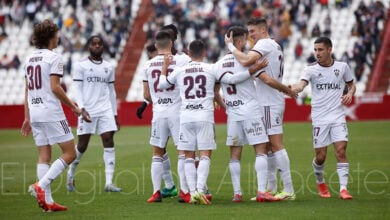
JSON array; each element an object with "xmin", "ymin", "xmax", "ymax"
[{"xmin": 21, "ymin": 20, "xmax": 81, "ymax": 212}]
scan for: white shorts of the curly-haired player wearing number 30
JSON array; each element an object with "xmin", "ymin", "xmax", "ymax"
[{"xmin": 31, "ymin": 119, "xmax": 73, "ymax": 146}]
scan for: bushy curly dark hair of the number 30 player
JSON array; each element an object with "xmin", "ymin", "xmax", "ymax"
[{"xmin": 32, "ymin": 19, "xmax": 59, "ymax": 48}]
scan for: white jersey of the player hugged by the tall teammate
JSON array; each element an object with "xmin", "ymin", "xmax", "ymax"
[{"xmin": 215, "ymin": 53, "xmax": 261, "ymax": 121}]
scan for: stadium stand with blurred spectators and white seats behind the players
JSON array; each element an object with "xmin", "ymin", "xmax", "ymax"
[{"xmin": 0, "ymin": 0, "xmax": 390, "ymax": 105}]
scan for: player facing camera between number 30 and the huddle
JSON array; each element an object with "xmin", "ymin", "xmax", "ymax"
[{"xmin": 66, "ymin": 35, "xmax": 121, "ymax": 192}]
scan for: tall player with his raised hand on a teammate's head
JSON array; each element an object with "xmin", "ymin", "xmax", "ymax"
[{"xmin": 225, "ymin": 17, "xmax": 297, "ymax": 200}]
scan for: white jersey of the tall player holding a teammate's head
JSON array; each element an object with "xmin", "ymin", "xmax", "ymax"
[{"xmin": 252, "ymin": 38, "xmax": 284, "ymax": 106}]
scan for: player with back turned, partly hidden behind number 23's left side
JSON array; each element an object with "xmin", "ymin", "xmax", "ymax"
[{"xmin": 143, "ymin": 31, "xmax": 188, "ymax": 202}]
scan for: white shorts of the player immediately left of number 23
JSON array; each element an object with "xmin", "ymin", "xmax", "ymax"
[{"xmin": 150, "ymin": 115, "xmax": 180, "ymax": 148}]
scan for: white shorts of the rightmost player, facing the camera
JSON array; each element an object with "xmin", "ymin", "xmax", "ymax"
[{"xmin": 312, "ymin": 123, "xmax": 348, "ymax": 148}]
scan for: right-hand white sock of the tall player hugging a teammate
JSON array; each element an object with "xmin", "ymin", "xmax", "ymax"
[{"xmin": 274, "ymin": 149, "xmax": 294, "ymax": 193}]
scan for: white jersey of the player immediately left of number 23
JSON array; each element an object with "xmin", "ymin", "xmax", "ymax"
[{"xmin": 142, "ymin": 55, "xmax": 189, "ymax": 120}]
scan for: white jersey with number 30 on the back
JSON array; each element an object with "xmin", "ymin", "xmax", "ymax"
[{"xmin": 23, "ymin": 49, "xmax": 65, "ymax": 122}]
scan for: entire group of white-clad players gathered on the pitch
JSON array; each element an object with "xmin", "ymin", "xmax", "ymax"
[{"xmin": 21, "ymin": 17, "xmax": 356, "ymax": 212}]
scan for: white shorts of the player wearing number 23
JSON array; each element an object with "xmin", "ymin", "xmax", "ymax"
[{"xmin": 177, "ymin": 121, "xmax": 217, "ymax": 151}]
